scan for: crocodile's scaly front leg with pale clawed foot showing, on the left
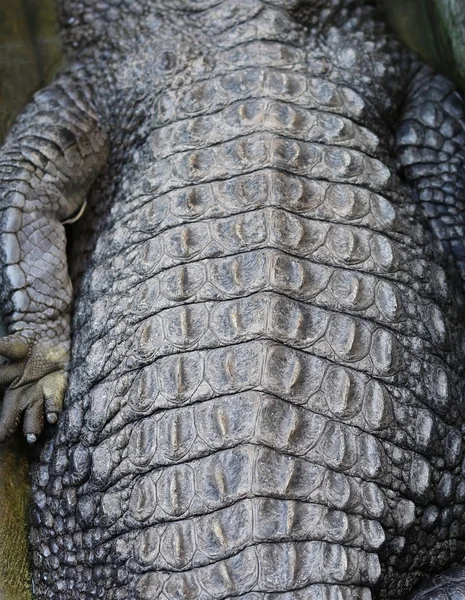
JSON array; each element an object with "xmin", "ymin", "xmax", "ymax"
[{"xmin": 0, "ymin": 73, "xmax": 107, "ymax": 442}]
